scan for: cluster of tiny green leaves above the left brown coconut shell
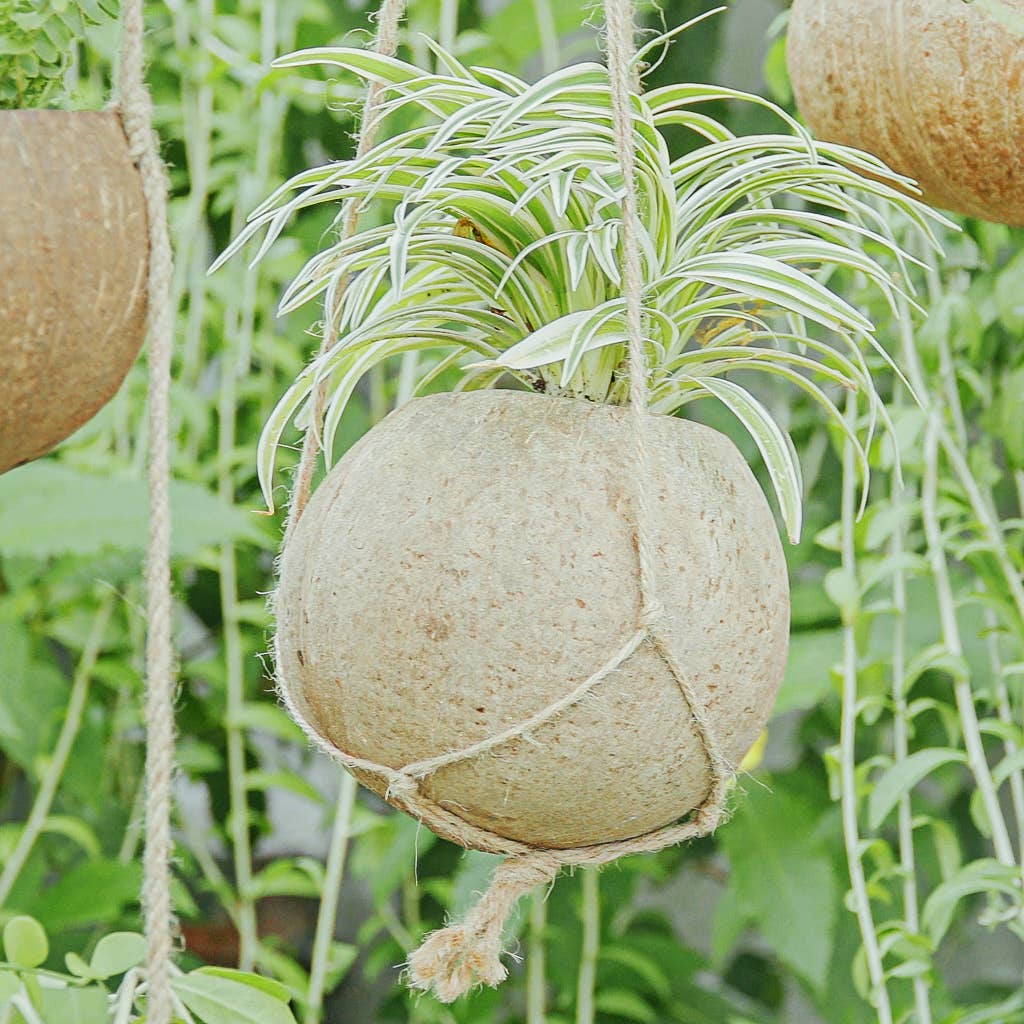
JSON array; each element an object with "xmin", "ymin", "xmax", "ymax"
[{"xmin": 0, "ymin": 0, "xmax": 116, "ymax": 110}]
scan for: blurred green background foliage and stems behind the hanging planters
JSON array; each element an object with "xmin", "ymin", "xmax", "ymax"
[{"xmin": 0, "ymin": 0, "xmax": 1024, "ymax": 1024}]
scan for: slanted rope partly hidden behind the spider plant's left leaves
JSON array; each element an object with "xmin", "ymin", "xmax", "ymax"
[{"xmin": 285, "ymin": 0, "xmax": 406, "ymax": 545}]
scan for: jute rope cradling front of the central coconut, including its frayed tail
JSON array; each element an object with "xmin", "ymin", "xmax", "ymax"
[{"xmin": 278, "ymin": 0, "xmax": 734, "ymax": 1002}]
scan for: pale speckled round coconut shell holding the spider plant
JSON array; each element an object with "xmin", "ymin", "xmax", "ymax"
[{"xmin": 276, "ymin": 391, "xmax": 788, "ymax": 848}]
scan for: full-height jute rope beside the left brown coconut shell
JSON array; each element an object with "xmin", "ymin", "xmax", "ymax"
[{"xmin": 114, "ymin": 0, "xmax": 175, "ymax": 1024}]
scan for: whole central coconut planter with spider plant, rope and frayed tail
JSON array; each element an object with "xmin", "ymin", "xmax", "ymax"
[{"xmin": 222, "ymin": 9, "xmax": 942, "ymax": 1000}]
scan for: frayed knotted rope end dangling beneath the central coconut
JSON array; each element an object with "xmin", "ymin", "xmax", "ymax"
[{"xmin": 409, "ymin": 851, "xmax": 562, "ymax": 1002}]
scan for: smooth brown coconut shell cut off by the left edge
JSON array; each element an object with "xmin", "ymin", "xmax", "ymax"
[{"xmin": 0, "ymin": 111, "xmax": 148, "ymax": 472}]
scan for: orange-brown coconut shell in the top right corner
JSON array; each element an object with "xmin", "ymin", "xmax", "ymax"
[{"xmin": 787, "ymin": 0, "xmax": 1024, "ymax": 224}]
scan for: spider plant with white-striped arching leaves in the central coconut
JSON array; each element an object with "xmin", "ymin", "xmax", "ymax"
[{"xmin": 215, "ymin": 27, "xmax": 939, "ymax": 540}]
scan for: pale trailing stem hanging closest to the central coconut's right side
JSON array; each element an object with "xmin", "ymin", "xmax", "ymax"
[{"xmin": 840, "ymin": 396, "xmax": 893, "ymax": 1024}]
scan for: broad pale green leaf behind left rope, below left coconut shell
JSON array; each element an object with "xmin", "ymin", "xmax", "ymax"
[{"xmin": 0, "ymin": 460, "xmax": 272, "ymax": 558}]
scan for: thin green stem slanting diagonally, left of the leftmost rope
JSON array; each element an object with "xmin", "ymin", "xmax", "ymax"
[{"xmin": 0, "ymin": 591, "xmax": 115, "ymax": 907}]
